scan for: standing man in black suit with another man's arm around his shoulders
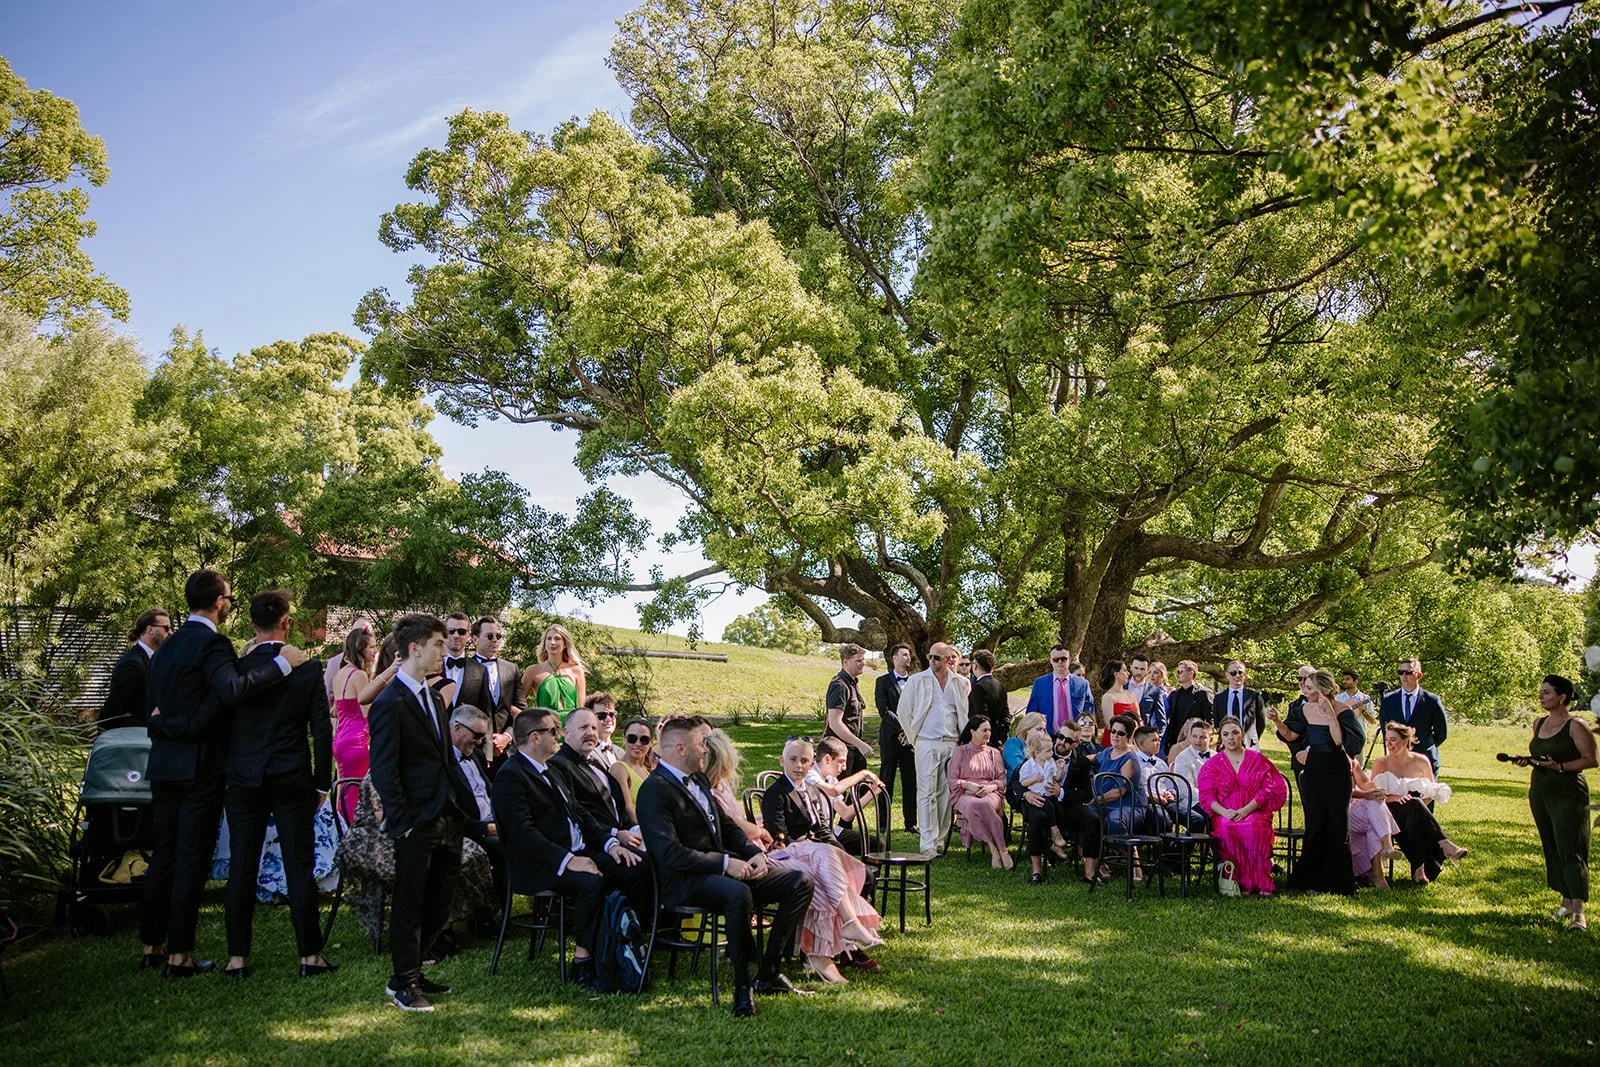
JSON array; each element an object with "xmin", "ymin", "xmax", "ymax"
[{"xmin": 222, "ymin": 590, "xmax": 338, "ymax": 979}]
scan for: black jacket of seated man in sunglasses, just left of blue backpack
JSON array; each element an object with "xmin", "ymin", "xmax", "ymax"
[{"xmin": 493, "ymin": 752, "xmax": 611, "ymax": 893}]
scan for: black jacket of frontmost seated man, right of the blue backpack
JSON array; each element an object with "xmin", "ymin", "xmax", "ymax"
[{"xmin": 638, "ymin": 765, "xmax": 762, "ymax": 905}]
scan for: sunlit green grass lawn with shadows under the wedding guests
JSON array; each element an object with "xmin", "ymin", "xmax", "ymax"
[{"xmin": 0, "ymin": 723, "xmax": 1600, "ymax": 1065}]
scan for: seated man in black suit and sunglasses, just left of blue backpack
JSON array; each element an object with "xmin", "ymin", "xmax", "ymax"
[{"xmin": 494, "ymin": 707, "xmax": 650, "ymax": 985}]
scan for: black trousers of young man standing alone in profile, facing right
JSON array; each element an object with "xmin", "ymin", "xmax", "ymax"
[{"xmin": 389, "ymin": 816, "xmax": 462, "ymax": 990}]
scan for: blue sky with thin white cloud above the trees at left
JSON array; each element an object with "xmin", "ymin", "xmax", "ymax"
[{"xmin": 0, "ymin": 0, "xmax": 765, "ymax": 637}]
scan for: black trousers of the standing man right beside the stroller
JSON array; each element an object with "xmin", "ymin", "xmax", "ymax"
[{"xmin": 139, "ymin": 776, "xmax": 222, "ymax": 955}]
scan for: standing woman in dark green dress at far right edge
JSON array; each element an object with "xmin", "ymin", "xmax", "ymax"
[{"xmin": 1528, "ymin": 675, "xmax": 1595, "ymax": 929}]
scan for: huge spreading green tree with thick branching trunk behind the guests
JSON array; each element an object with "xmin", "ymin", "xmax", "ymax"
[{"xmin": 360, "ymin": 0, "xmax": 1568, "ymax": 681}]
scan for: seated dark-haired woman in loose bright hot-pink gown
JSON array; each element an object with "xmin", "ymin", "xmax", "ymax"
[{"xmin": 1198, "ymin": 715, "xmax": 1288, "ymax": 894}]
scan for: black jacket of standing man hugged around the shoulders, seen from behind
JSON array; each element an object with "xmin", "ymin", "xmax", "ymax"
[{"xmin": 227, "ymin": 643, "xmax": 333, "ymax": 792}]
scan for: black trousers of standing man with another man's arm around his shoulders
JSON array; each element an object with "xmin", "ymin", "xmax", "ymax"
[{"xmin": 224, "ymin": 774, "xmax": 322, "ymax": 957}]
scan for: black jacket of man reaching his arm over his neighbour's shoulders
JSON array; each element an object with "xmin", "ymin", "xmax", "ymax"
[{"xmin": 146, "ymin": 622, "xmax": 283, "ymax": 782}]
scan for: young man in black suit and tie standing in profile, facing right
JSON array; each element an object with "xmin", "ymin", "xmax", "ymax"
[{"xmin": 366, "ymin": 614, "xmax": 478, "ymax": 1011}]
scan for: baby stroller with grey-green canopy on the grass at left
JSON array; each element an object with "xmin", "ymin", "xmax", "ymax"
[{"xmin": 56, "ymin": 726, "xmax": 150, "ymax": 937}]
